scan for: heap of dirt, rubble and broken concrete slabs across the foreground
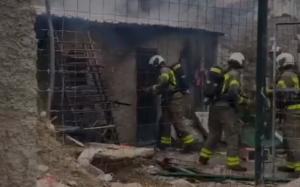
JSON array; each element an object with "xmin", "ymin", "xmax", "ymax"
[{"xmin": 37, "ymin": 119, "xmax": 299, "ymax": 187}]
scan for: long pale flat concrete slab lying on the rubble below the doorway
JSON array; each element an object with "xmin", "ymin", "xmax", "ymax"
[{"xmin": 88, "ymin": 143, "xmax": 154, "ymax": 160}]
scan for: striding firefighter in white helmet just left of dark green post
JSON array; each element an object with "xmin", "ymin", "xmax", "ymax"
[{"xmin": 199, "ymin": 52, "xmax": 249, "ymax": 171}]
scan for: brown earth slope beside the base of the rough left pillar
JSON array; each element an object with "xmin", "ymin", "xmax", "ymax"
[{"xmin": 37, "ymin": 122, "xmax": 104, "ymax": 187}]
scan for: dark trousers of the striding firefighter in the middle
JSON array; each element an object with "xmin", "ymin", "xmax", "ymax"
[{"xmin": 200, "ymin": 106, "xmax": 240, "ymax": 158}]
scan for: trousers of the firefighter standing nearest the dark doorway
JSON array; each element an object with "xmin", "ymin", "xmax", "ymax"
[{"xmin": 160, "ymin": 93, "xmax": 195, "ymax": 145}]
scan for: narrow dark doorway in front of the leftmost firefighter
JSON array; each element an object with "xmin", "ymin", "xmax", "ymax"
[{"xmin": 136, "ymin": 48, "xmax": 159, "ymax": 145}]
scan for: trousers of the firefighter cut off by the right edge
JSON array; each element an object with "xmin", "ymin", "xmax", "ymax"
[{"xmin": 283, "ymin": 111, "xmax": 300, "ymax": 171}]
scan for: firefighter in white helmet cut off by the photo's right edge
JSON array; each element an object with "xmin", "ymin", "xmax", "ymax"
[{"xmin": 276, "ymin": 53, "xmax": 300, "ymax": 174}]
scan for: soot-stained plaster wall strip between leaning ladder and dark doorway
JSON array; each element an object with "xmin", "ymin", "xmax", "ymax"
[{"xmin": 89, "ymin": 25, "xmax": 137, "ymax": 144}]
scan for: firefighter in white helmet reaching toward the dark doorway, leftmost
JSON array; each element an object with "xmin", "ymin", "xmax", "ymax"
[{"xmin": 147, "ymin": 55, "xmax": 195, "ymax": 149}]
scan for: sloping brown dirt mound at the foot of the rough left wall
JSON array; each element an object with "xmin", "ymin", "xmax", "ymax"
[{"xmin": 37, "ymin": 122, "xmax": 104, "ymax": 187}]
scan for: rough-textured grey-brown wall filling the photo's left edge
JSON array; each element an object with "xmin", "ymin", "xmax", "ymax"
[{"xmin": 0, "ymin": 0, "xmax": 37, "ymax": 187}]
